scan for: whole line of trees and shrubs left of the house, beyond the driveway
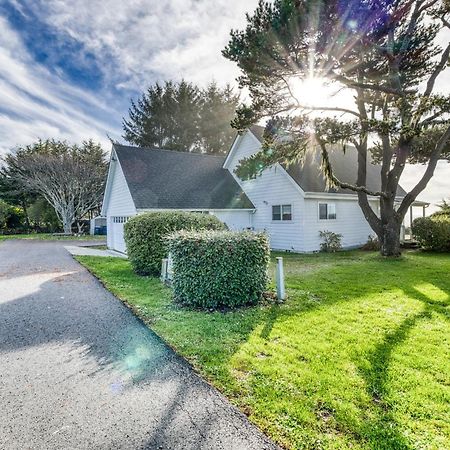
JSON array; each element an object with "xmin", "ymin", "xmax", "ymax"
[{"xmin": 0, "ymin": 140, "xmax": 107, "ymax": 233}]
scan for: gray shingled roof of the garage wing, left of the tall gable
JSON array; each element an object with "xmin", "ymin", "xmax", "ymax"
[{"xmin": 113, "ymin": 144, "xmax": 254, "ymax": 209}]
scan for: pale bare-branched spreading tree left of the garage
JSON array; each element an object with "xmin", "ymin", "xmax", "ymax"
[{"xmin": 2, "ymin": 140, "xmax": 107, "ymax": 233}]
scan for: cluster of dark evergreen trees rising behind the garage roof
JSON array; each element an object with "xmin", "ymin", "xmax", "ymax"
[{"xmin": 123, "ymin": 81, "xmax": 239, "ymax": 153}]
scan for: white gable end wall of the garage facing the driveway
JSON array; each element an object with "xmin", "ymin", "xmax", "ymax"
[{"xmin": 105, "ymin": 156, "xmax": 136, "ymax": 252}]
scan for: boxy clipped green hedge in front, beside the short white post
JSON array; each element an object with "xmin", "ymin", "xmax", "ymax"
[{"xmin": 167, "ymin": 231, "xmax": 270, "ymax": 309}]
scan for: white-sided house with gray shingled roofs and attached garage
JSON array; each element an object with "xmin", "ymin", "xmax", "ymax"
[{"xmin": 102, "ymin": 126, "xmax": 405, "ymax": 252}]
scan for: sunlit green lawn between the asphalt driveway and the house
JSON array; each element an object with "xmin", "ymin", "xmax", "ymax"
[{"xmin": 77, "ymin": 252, "xmax": 450, "ymax": 449}]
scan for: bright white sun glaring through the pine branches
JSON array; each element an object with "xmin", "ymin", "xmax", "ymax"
[{"xmin": 289, "ymin": 77, "xmax": 333, "ymax": 107}]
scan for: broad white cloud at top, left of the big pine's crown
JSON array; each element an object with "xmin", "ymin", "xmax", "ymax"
[{"xmin": 20, "ymin": 0, "xmax": 257, "ymax": 91}]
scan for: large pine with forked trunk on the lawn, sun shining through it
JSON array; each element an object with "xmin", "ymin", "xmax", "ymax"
[{"xmin": 223, "ymin": 0, "xmax": 450, "ymax": 256}]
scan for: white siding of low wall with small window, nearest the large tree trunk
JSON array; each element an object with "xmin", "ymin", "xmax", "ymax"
[{"xmin": 303, "ymin": 198, "xmax": 378, "ymax": 252}]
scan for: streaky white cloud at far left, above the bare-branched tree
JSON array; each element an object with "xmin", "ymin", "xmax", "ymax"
[{"xmin": 0, "ymin": 17, "xmax": 115, "ymax": 154}]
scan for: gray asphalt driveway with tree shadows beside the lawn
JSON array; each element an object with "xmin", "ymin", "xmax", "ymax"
[{"xmin": 0, "ymin": 240, "xmax": 276, "ymax": 450}]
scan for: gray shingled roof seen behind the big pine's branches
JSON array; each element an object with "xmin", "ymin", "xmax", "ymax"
[{"xmin": 250, "ymin": 125, "xmax": 406, "ymax": 197}]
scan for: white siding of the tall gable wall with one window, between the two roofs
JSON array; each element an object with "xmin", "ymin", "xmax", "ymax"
[{"xmin": 227, "ymin": 132, "xmax": 304, "ymax": 252}]
